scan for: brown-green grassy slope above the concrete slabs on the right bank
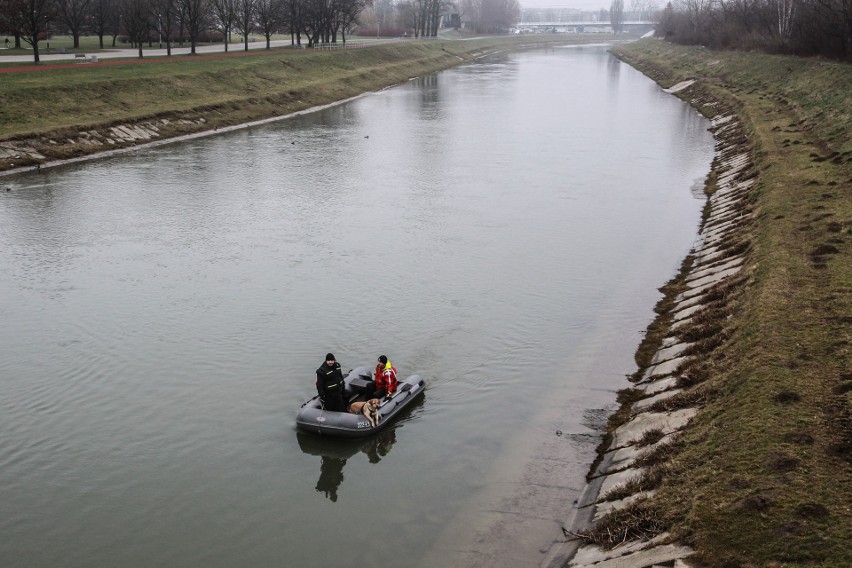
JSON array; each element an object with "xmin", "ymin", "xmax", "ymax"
[{"xmin": 617, "ymin": 40, "xmax": 852, "ymax": 567}]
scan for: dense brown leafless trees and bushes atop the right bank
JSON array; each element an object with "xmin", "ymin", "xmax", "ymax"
[{"xmin": 657, "ymin": 0, "xmax": 852, "ymax": 61}]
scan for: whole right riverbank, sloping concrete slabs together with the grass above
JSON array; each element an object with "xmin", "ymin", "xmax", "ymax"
[{"xmin": 550, "ymin": 42, "xmax": 852, "ymax": 568}]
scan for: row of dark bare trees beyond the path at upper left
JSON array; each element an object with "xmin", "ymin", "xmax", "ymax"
[{"xmin": 0, "ymin": 0, "xmax": 368, "ymax": 62}]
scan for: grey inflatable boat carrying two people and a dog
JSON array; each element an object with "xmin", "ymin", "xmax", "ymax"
[{"xmin": 296, "ymin": 367, "xmax": 425, "ymax": 438}]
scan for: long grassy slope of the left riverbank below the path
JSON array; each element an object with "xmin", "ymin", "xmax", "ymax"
[{"xmin": 0, "ymin": 35, "xmax": 612, "ymax": 170}]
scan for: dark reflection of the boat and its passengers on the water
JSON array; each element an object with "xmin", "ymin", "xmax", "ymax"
[{"xmin": 296, "ymin": 397, "xmax": 424, "ymax": 503}]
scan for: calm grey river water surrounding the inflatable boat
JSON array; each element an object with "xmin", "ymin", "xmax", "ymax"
[{"xmin": 0, "ymin": 47, "xmax": 713, "ymax": 567}]
